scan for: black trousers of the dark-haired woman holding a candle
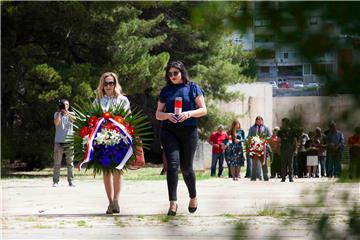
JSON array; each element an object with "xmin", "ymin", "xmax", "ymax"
[{"xmin": 160, "ymin": 126, "xmax": 198, "ymax": 201}]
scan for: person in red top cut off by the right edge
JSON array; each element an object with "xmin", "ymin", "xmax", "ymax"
[{"xmin": 348, "ymin": 126, "xmax": 360, "ymax": 179}]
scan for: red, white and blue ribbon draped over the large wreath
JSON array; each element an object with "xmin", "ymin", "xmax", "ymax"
[{"xmin": 79, "ymin": 117, "xmax": 133, "ymax": 171}]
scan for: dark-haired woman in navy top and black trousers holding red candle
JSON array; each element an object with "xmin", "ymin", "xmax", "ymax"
[{"xmin": 156, "ymin": 61, "xmax": 207, "ymax": 216}]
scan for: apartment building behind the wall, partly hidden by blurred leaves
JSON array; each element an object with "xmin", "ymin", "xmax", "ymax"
[{"xmin": 232, "ymin": 2, "xmax": 341, "ymax": 87}]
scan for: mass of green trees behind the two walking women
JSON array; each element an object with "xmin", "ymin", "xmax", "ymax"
[{"xmin": 1, "ymin": 2, "xmax": 254, "ymax": 168}]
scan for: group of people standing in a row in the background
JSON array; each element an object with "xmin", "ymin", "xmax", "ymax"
[{"xmin": 209, "ymin": 116, "xmax": 360, "ymax": 182}]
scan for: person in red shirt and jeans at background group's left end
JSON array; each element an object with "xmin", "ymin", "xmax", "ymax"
[{"xmin": 209, "ymin": 125, "xmax": 228, "ymax": 177}]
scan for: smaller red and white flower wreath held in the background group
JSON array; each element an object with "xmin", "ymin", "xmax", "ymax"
[{"xmin": 245, "ymin": 135, "xmax": 269, "ymax": 164}]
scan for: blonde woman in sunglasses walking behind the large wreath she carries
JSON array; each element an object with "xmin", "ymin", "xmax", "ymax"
[{"xmin": 94, "ymin": 72, "xmax": 130, "ymax": 214}]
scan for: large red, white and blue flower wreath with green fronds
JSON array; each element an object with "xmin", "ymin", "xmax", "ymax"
[{"xmin": 68, "ymin": 100, "xmax": 151, "ymax": 175}]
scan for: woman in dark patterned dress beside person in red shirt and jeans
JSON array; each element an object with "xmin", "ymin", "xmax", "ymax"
[{"xmin": 224, "ymin": 120, "xmax": 245, "ymax": 181}]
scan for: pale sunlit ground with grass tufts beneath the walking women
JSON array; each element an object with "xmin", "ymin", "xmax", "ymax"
[{"xmin": 1, "ymin": 177, "xmax": 360, "ymax": 239}]
